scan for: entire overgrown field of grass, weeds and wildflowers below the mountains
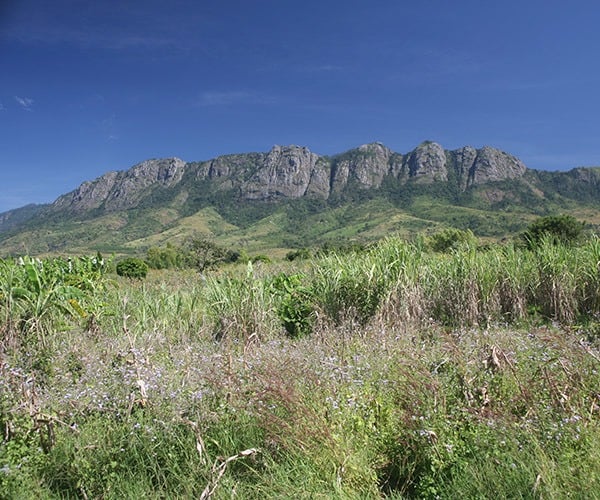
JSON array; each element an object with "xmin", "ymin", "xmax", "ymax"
[{"xmin": 0, "ymin": 229, "xmax": 600, "ymax": 498}]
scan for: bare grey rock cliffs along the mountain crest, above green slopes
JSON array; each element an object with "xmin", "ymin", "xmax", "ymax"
[{"xmin": 51, "ymin": 142, "xmax": 526, "ymax": 212}]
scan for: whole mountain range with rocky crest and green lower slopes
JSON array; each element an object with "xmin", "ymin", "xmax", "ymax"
[{"xmin": 0, "ymin": 141, "xmax": 600, "ymax": 254}]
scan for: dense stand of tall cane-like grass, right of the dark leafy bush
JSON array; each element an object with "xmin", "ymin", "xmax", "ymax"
[{"xmin": 313, "ymin": 238, "xmax": 600, "ymax": 326}]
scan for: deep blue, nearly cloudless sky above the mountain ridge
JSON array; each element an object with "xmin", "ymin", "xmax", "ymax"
[{"xmin": 0, "ymin": 0, "xmax": 600, "ymax": 212}]
